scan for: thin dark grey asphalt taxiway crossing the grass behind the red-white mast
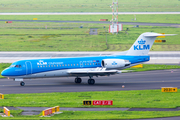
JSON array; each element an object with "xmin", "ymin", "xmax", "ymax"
[{"xmin": 0, "ymin": 20, "xmax": 180, "ymax": 28}]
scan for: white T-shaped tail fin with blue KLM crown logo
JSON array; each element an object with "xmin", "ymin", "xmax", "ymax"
[{"xmin": 126, "ymin": 32, "xmax": 176, "ymax": 56}]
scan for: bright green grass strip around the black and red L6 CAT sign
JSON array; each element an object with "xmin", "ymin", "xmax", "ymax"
[{"xmin": 0, "ymin": 89, "xmax": 180, "ymax": 108}]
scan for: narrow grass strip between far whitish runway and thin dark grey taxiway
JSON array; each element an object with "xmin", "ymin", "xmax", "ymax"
[{"xmin": 0, "ymin": 14, "xmax": 180, "ymax": 24}]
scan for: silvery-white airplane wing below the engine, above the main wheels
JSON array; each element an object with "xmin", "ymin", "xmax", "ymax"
[{"xmin": 68, "ymin": 69, "xmax": 121, "ymax": 76}]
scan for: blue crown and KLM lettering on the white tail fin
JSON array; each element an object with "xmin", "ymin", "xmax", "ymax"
[{"xmin": 134, "ymin": 39, "xmax": 150, "ymax": 50}]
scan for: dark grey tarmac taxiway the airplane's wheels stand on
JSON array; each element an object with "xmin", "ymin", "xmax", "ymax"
[{"xmin": 0, "ymin": 69, "xmax": 180, "ymax": 94}]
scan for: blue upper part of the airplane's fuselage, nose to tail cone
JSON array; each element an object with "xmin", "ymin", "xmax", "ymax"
[{"xmin": 1, "ymin": 55, "xmax": 150, "ymax": 77}]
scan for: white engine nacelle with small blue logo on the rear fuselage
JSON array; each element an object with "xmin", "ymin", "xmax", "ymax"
[{"xmin": 101, "ymin": 59, "xmax": 131, "ymax": 69}]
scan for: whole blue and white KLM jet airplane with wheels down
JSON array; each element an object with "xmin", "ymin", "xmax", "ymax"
[{"xmin": 1, "ymin": 32, "xmax": 176, "ymax": 86}]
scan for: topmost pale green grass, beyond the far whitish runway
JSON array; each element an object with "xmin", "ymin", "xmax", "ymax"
[{"xmin": 0, "ymin": 0, "xmax": 180, "ymax": 12}]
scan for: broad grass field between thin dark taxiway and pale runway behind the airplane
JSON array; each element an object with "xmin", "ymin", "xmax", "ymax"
[{"xmin": 0, "ymin": 21, "xmax": 180, "ymax": 51}]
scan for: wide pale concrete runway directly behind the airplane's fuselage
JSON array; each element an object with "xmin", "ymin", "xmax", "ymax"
[{"xmin": 0, "ymin": 51, "xmax": 180, "ymax": 65}]
